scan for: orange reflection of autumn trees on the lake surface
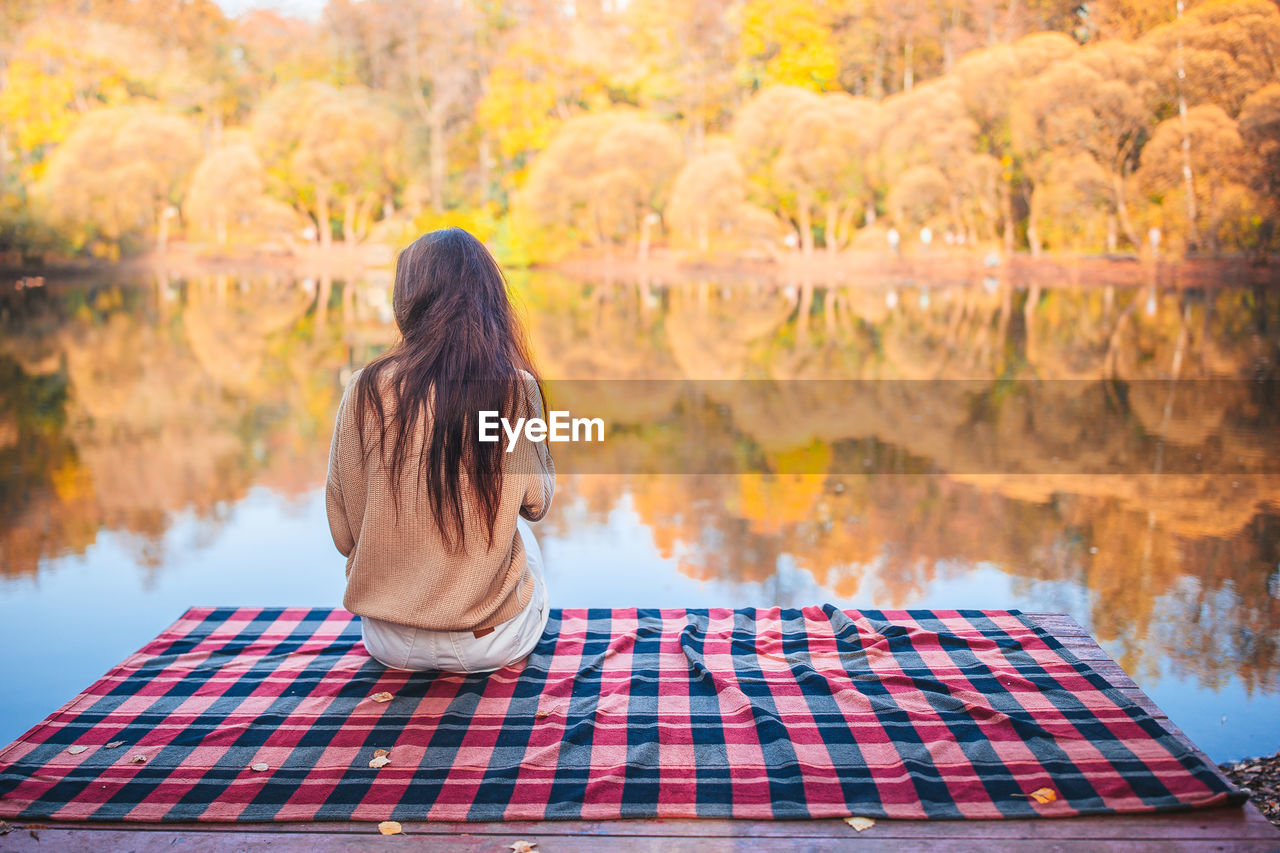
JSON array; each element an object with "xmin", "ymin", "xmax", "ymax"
[{"xmin": 0, "ymin": 273, "xmax": 1280, "ymax": 749}]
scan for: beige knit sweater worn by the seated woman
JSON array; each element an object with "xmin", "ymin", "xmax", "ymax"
[{"xmin": 325, "ymin": 361, "xmax": 556, "ymax": 630}]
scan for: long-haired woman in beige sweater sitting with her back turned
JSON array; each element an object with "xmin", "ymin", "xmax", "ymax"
[{"xmin": 325, "ymin": 228, "xmax": 556, "ymax": 672}]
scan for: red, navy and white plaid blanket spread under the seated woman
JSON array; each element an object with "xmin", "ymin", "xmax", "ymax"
[{"xmin": 0, "ymin": 606, "xmax": 1243, "ymax": 821}]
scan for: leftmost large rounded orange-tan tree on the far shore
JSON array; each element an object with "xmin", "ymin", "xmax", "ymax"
[{"xmin": 38, "ymin": 106, "xmax": 200, "ymax": 252}]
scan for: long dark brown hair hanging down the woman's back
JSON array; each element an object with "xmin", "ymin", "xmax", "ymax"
[{"xmin": 356, "ymin": 228, "xmax": 547, "ymax": 551}]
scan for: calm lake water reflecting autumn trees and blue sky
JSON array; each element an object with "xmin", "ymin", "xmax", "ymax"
[{"xmin": 0, "ymin": 268, "xmax": 1280, "ymax": 761}]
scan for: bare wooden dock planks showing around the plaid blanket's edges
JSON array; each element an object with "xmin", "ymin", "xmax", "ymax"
[{"xmin": 0, "ymin": 613, "xmax": 1280, "ymax": 853}]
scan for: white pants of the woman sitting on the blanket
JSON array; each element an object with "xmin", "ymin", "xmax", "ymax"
[{"xmin": 360, "ymin": 519, "xmax": 550, "ymax": 672}]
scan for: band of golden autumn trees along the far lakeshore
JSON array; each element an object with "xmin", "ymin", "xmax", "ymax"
[{"xmin": 0, "ymin": 0, "xmax": 1280, "ymax": 265}]
